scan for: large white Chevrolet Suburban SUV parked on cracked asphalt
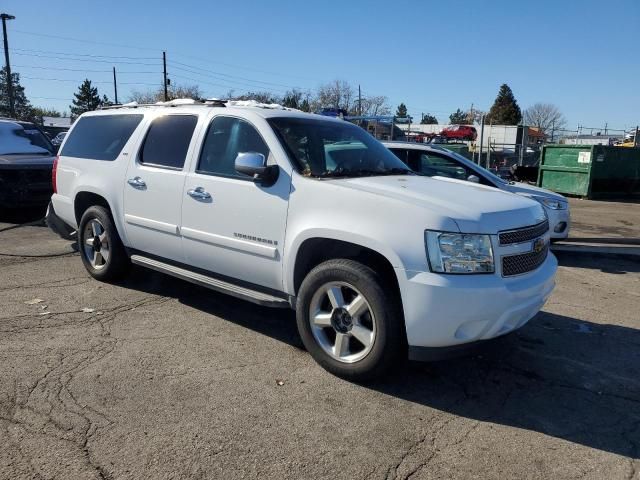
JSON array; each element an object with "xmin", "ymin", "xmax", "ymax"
[{"xmin": 49, "ymin": 101, "xmax": 557, "ymax": 379}]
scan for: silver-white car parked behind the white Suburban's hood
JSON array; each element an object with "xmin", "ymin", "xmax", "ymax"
[{"xmin": 383, "ymin": 142, "xmax": 571, "ymax": 241}]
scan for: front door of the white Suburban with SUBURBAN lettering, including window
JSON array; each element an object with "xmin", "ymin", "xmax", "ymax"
[{"xmin": 181, "ymin": 116, "xmax": 291, "ymax": 291}]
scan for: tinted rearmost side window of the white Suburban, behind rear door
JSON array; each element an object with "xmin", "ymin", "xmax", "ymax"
[{"xmin": 60, "ymin": 115, "xmax": 142, "ymax": 161}]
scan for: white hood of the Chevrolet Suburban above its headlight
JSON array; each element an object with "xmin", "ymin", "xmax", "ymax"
[{"xmin": 331, "ymin": 175, "xmax": 546, "ymax": 234}]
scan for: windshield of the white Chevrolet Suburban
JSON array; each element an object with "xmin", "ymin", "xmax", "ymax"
[{"xmin": 268, "ymin": 117, "xmax": 413, "ymax": 177}]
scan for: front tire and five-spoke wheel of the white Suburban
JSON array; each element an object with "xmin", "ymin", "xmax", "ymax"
[{"xmin": 296, "ymin": 259, "xmax": 406, "ymax": 381}]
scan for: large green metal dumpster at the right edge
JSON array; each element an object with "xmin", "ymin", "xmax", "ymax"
[{"xmin": 538, "ymin": 145, "xmax": 640, "ymax": 198}]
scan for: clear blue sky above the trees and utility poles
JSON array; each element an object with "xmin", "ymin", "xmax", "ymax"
[{"xmin": 0, "ymin": 0, "xmax": 640, "ymax": 128}]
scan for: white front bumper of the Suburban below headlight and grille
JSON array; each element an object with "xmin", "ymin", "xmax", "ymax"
[{"xmin": 396, "ymin": 253, "xmax": 558, "ymax": 348}]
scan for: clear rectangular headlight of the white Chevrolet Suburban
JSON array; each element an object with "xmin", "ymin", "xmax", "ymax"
[{"xmin": 424, "ymin": 230, "xmax": 494, "ymax": 273}]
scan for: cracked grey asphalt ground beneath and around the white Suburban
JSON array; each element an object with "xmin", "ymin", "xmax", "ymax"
[{"xmin": 0, "ymin": 212, "xmax": 640, "ymax": 479}]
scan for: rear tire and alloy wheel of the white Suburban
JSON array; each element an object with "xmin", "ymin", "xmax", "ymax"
[{"xmin": 77, "ymin": 206, "xmax": 130, "ymax": 282}]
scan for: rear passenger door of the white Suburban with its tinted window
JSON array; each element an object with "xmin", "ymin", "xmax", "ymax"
[{"xmin": 124, "ymin": 114, "xmax": 198, "ymax": 262}]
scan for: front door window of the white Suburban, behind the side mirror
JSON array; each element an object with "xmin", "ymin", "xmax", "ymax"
[{"xmin": 196, "ymin": 117, "xmax": 269, "ymax": 178}]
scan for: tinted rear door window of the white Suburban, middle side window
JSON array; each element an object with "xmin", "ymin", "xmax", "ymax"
[{"xmin": 138, "ymin": 115, "xmax": 198, "ymax": 170}]
